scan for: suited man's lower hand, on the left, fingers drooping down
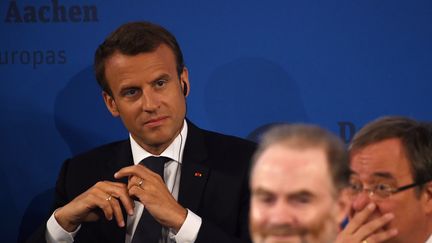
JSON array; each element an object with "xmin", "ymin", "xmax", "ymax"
[{"xmin": 54, "ymin": 181, "xmax": 134, "ymax": 232}]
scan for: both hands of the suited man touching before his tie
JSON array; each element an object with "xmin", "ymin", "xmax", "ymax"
[{"xmin": 54, "ymin": 165, "xmax": 187, "ymax": 232}]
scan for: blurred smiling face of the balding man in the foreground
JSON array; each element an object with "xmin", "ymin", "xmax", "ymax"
[{"xmin": 250, "ymin": 144, "xmax": 344, "ymax": 243}]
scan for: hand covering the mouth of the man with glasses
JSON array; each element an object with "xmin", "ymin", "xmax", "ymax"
[{"xmin": 336, "ymin": 203, "xmax": 398, "ymax": 243}]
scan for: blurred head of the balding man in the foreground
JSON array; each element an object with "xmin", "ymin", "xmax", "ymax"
[{"xmin": 249, "ymin": 125, "xmax": 349, "ymax": 243}]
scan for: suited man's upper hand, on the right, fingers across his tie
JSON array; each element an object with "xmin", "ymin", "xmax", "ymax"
[{"xmin": 114, "ymin": 165, "xmax": 187, "ymax": 231}]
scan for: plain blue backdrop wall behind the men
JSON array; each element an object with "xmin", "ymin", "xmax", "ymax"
[{"xmin": 0, "ymin": 0, "xmax": 432, "ymax": 242}]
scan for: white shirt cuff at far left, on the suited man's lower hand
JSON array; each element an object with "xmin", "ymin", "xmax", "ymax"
[{"xmin": 45, "ymin": 212, "xmax": 81, "ymax": 243}]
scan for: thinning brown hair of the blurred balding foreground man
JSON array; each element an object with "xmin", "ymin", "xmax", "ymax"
[{"xmin": 252, "ymin": 124, "xmax": 350, "ymax": 192}]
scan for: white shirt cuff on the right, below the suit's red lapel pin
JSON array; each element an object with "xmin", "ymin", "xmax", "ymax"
[{"xmin": 169, "ymin": 209, "xmax": 202, "ymax": 243}]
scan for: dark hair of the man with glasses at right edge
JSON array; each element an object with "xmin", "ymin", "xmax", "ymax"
[{"xmin": 349, "ymin": 116, "xmax": 432, "ymax": 188}]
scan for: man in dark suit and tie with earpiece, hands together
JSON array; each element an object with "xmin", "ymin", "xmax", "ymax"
[{"xmin": 27, "ymin": 22, "xmax": 255, "ymax": 243}]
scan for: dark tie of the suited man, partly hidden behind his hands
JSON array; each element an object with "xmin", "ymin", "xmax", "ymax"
[{"xmin": 131, "ymin": 156, "xmax": 171, "ymax": 243}]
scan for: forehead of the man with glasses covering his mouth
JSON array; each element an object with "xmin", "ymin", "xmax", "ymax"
[{"xmin": 351, "ymin": 138, "xmax": 412, "ymax": 180}]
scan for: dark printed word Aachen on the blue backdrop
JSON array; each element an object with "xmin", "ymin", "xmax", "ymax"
[{"xmin": 4, "ymin": 0, "xmax": 98, "ymax": 23}]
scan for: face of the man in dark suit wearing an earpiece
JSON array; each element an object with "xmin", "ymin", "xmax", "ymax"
[{"xmin": 103, "ymin": 44, "xmax": 190, "ymax": 154}]
